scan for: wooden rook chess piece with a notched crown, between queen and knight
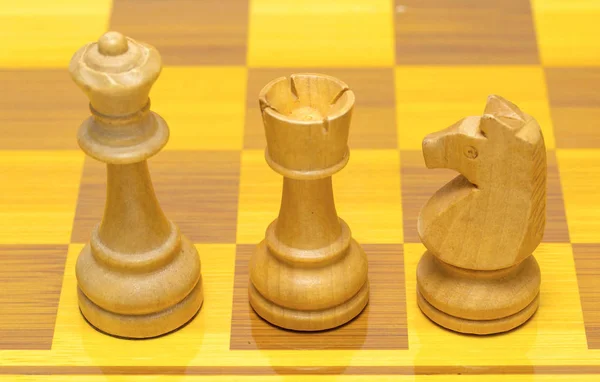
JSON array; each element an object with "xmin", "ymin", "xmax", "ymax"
[{"xmin": 249, "ymin": 74, "xmax": 369, "ymax": 331}]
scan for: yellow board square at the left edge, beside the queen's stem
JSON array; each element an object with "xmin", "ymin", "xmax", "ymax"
[{"xmin": 0, "ymin": 150, "xmax": 83, "ymax": 244}]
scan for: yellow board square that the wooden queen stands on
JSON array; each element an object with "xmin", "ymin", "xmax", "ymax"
[{"xmin": 52, "ymin": 244, "xmax": 235, "ymax": 358}]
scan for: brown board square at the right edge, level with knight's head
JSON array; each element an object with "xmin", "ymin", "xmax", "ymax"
[{"xmin": 546, "ymin": 68, "xmax": 600, "ymax": 148}]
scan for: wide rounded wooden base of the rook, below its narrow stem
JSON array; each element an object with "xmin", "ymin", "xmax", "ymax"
[{"xmin": 248, "ymin": 230, "xmax": 369, "ymax": 331}]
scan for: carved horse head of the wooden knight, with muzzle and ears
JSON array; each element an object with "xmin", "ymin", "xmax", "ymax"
[{"xmin": 423, "ymin": 95, "xmax": 545, "ymax": 186}]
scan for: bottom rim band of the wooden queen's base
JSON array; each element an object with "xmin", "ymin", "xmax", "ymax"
[{"xmin": 77, "ymin": 279, "xmax": 204, "ymax": 338}]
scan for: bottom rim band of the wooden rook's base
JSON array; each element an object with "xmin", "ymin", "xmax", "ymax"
[{"xmin": 248, "ymin": 281, "xmax": 369, "ymax": 331}]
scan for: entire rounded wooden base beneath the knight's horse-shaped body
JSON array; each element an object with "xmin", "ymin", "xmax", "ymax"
[{"xmin": 417, "ymin": 251, "xmax": 541, "ymax": 334}]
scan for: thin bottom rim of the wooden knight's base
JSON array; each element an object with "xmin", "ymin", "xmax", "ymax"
[{"xmin": 417, "ymin": 292, "xmax": 539, "ymax": 335}]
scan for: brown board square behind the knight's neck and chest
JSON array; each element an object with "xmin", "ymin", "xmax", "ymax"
[{"xmin": 400, "ymin": 151, "xmax": 569, "ymax": 243}]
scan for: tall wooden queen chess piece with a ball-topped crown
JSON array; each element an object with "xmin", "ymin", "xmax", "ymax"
[{"xmin": 69, "ymin": 32, "xmax": 203, "ymax": 338}]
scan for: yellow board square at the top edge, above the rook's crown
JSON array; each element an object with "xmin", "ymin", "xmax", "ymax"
[{"xmin": 248, "ymin": 0, "xmax": 395, "ymax": 67}]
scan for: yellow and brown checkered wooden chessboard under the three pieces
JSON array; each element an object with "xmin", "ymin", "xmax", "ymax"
[{"xmin": 0, "ymin": 0, "xmax": 600, "ymax": 382}]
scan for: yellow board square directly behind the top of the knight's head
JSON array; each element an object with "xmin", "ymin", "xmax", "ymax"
[{"xmin": 395, "ymin": 66, "xmax": 555, "ymax": 150}]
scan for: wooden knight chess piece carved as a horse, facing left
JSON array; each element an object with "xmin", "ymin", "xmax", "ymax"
[{"xmin": 417, "ymin": 96, "xmax": 546, "ymax": 334}]
